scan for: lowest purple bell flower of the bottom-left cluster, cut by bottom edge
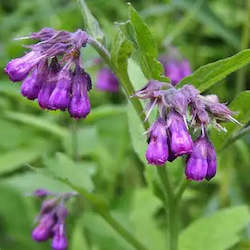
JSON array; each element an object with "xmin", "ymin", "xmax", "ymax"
[{"xmin": 51, "ymin": 223, "xmax": 68, "ymax": 250}]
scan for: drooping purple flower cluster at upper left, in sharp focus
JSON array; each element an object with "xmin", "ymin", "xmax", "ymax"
[{"xmin": 5, "ymin": 28, "xmax": 91, "ymax": 119}]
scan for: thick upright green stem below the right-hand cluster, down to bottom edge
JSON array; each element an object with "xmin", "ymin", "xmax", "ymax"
[{"xmin": 157, "ymin": 166, "xmax": 178, "ymax": 250}]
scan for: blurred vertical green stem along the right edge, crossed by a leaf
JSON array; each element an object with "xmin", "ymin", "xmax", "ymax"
[{"xmin": 236, "ymin": 0, "xmax": 250, "ymax": 94}]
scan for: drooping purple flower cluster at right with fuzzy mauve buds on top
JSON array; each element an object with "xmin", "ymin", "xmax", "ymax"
[{"xmin": 134, "ymin": 80, "xmax": 237, "ymax": 181}]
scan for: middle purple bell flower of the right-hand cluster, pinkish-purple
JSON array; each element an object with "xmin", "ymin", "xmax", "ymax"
[{"xmin": 168, "ymin": 111, "xmax": 193, "ymax": 156}]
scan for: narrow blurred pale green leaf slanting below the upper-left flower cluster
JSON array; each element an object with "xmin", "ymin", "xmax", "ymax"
[{"xmin": 4, "ymin": 111, "xmax": 67, "ymax": 137}]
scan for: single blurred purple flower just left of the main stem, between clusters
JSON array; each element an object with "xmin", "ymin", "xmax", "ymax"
[{"xmin": 96, "ymin": 68, "xmax": 119, "ymax": 92}]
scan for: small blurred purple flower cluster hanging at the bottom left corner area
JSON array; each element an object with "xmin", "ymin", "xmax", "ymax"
[{"xmin": 32, "ymin": 189, "xmax": 73, "ymax": 250}]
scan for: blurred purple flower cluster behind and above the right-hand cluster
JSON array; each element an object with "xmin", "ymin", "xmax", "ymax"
[{"xmin": 160, "ymin": 48, "xmax": 192, "ymax": 86}]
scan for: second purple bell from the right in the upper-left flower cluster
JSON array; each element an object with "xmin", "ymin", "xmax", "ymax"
[{"xmin": 49, "ymin": 69, "xmax": 72, "ymax": 110}]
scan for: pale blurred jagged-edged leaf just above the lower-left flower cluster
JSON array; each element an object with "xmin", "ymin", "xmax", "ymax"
[{"xmin": 44, "ymin": 153, "xmax": 96, "ymax": 192}]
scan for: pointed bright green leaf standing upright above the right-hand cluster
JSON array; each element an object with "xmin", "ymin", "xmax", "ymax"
[{"xmin": 129, "ymin": 5, "xmax": 169, "ymax": 82}]
